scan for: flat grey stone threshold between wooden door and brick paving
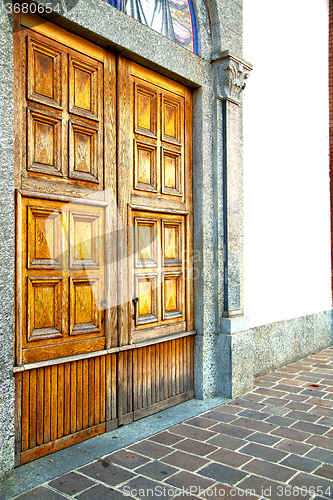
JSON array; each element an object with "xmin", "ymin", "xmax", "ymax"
[{"xmin": 1, "ymin": 397, "xmax": 229, "ymax": 500}]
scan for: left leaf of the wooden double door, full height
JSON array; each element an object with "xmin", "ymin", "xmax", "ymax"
[{"xmin": 14, "ymin": 15, "xmax": 117, "ymax": 463}]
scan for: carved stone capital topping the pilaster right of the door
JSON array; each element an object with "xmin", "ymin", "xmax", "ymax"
[{"xmin": 212, "ymin": 50, "xmax": 252, "ymax": 104}]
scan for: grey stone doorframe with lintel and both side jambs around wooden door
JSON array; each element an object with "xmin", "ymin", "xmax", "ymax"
[{"xmin": 0, "ymin": 0, "xmax": 253, "ymax": 480}]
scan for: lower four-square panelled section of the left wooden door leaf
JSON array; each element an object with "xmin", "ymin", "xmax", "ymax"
[{"xmin": 20, "ymin": 193, "xmax": 106, "ymax": 362}]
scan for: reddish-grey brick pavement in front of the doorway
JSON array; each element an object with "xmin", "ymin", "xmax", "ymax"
[{"xmin": 9, "ymin": 348, "xmax": 333, "ymax": 500}]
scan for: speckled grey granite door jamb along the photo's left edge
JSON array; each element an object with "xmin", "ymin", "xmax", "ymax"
[{"xmin": 0, "ymin": 2, "xmax": 15, "ymax": 480}]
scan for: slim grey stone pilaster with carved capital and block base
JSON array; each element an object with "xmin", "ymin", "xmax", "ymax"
[{"xmin": 212, "ymin": 51, "xmax": 253, "ymax": 397}]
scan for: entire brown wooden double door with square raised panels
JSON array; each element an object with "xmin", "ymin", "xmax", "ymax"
[{"xmin": 14, "ymin": 11, "xmax": 195, "ymax": 465}]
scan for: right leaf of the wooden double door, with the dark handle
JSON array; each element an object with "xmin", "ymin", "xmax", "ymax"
[{"xmin": 118, "ymin": 58, "xmax": 193, "ymax": 421}]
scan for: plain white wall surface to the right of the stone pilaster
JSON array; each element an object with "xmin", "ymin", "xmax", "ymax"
[{"xmin": 243, "ymin": 0, "xmax": 332, "ymax": 326}]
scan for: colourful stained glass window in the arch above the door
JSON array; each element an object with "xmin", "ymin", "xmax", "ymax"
[{"xmin": 104, "ymin": 0, "xmax": 198, "ymax": 54}]
